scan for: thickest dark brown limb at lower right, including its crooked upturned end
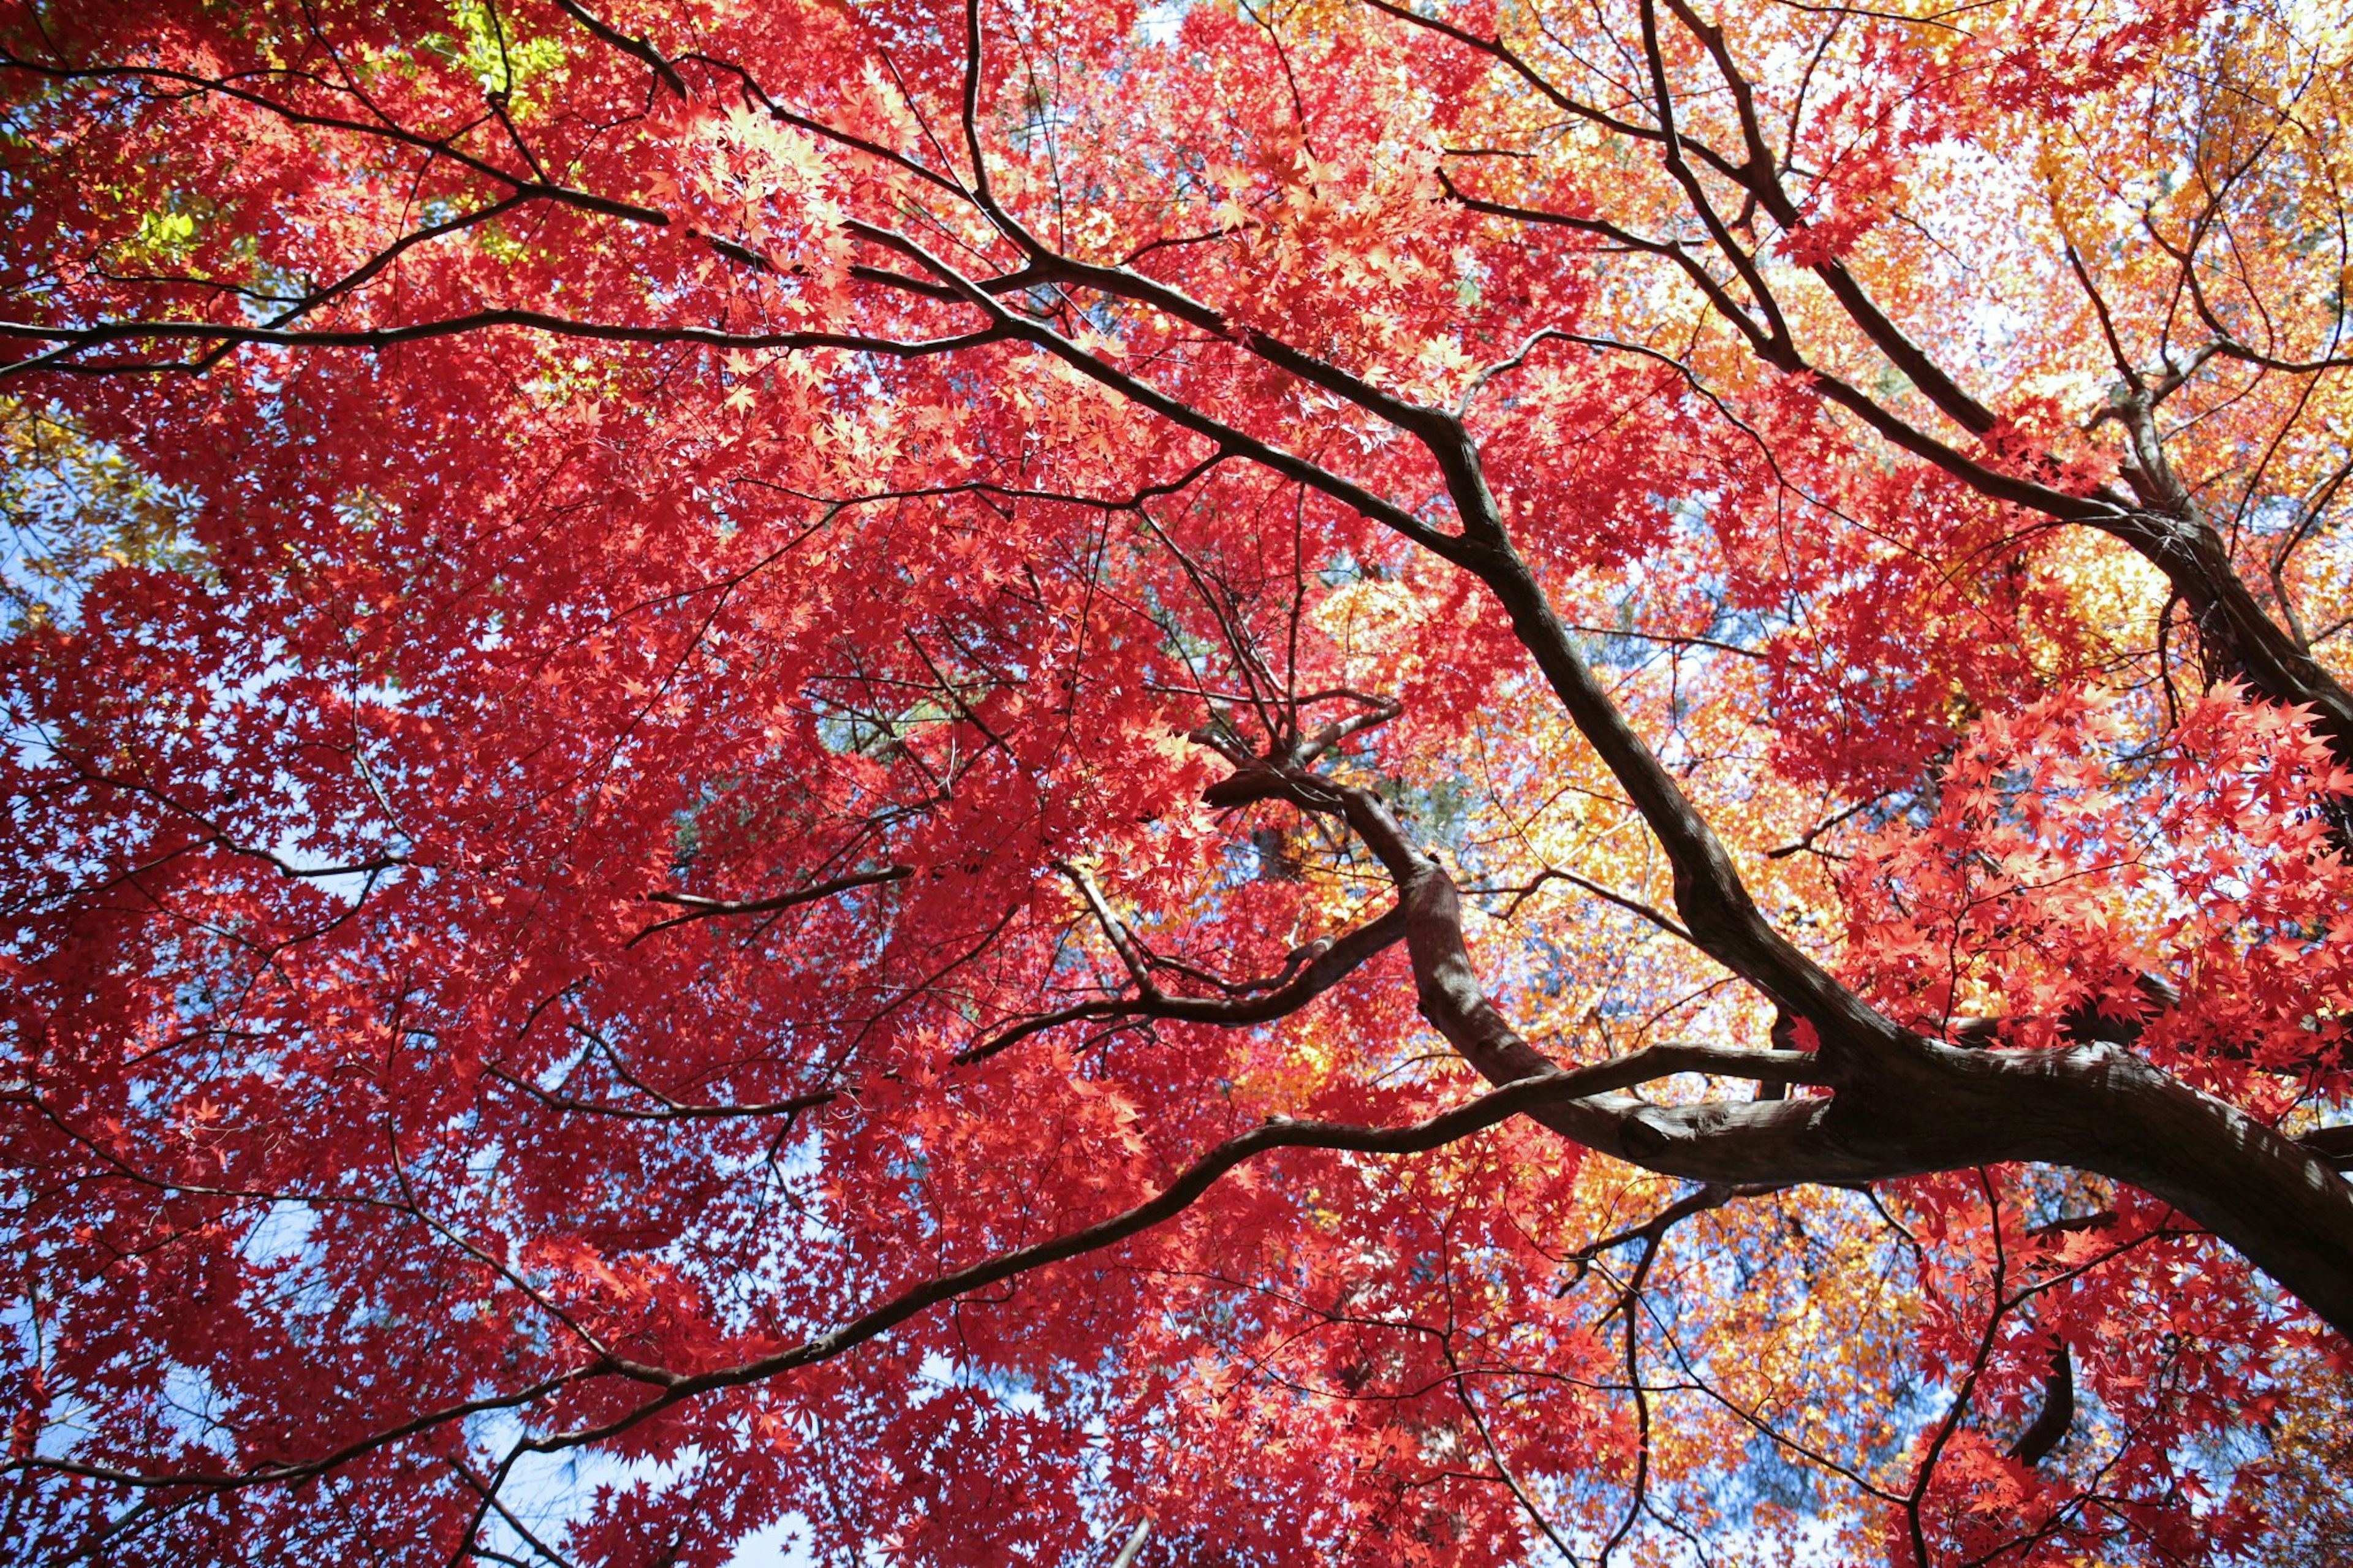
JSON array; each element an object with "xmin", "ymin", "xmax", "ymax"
[{"xmin": 1214, "ymin": 758, "xmax": 2353, "ymax": 1333}]
